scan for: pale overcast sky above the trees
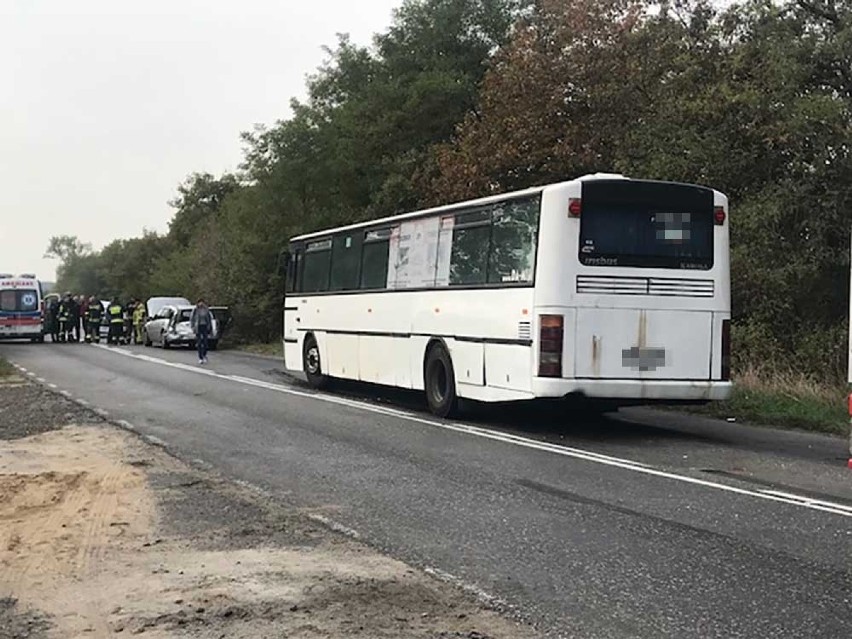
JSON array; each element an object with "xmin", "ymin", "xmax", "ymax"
[{"xmin": 0, "ymin": 0, "xmax": 401, "ymax": 280}]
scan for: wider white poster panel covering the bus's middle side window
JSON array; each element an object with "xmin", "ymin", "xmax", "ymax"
[{"xmin": 388, "ymin": 218, "xmax": 440, "ymax": 289}]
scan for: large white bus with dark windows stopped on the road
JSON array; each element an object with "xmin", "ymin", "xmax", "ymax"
[{"xmin": 284, "ymin": 174, "xmax": 731, "ymax": 417}]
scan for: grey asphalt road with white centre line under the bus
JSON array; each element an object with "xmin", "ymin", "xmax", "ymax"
[{"xmin": 0, "ymin": 344, "xmax": 852, "ymax": 639}]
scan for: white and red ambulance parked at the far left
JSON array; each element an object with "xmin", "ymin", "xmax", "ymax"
[{"xmin": 0, "ymin": 273, "xmax": 44, "ymax": 342}]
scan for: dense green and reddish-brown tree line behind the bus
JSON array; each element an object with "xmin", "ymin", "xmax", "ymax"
[{"xmin": 49, "ymin": 0, "xmax": 852, "ymax": 381}]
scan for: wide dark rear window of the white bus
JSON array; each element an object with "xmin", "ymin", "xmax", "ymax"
[{"xmin": 579, "ymin": 180, "xmax": 714, "ymax": 270}]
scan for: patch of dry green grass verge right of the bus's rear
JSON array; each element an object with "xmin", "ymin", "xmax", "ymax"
[{"xmin": 689, "ymin": 371, "xmax": 849, "ymax": 435}]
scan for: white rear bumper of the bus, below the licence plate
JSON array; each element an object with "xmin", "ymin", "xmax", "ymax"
[{"xmin": 532, "ymin": 377, "xmax": 733, "ymax": 402}]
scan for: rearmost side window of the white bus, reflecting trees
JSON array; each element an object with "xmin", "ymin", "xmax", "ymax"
[{"xmin": 488, "ymin": 196, "xmax": 541, "ymax": 284}]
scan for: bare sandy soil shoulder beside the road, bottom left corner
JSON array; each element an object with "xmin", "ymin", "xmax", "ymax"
[{"xmin": 0, "ymin": 384, "xmax": 537, "ymax": 639}]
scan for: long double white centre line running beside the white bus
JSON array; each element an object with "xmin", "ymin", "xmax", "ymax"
[{"xmin": 86, "ymin": 346, "xmax": 852, "ymax": 518}]
